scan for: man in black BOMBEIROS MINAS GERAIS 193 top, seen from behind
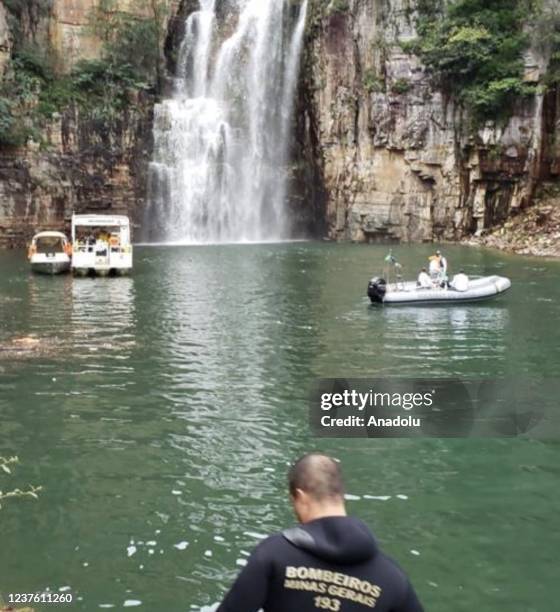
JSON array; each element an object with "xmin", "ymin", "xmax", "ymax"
[{"xmin": 218, "ymin": 453, "xmax": 423, "ymax": 612}]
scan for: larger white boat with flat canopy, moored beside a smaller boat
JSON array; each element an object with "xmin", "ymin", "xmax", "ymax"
[{"xmin": 72, "ymin": 215, "xmax": 132, "ymax": 276}]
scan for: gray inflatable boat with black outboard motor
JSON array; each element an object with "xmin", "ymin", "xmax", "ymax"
[{"xmin": 368, "ymin": 276, "xmax": 511, "ymax": 305}]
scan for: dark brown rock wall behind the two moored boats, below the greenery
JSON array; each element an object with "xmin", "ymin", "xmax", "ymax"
[{"xmin": 0, "ymin": 98, "xmax": 153, "ymax": 247}]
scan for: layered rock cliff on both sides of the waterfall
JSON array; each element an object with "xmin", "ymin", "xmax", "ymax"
[{"xmin": 0, "ymin": 0, "xmax": 560, "ymax": 246}]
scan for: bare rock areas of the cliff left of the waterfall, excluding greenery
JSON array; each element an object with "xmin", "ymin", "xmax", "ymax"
[{"xmin": 0, "ymin": 0, "xmax": 178, "ymax": 247}]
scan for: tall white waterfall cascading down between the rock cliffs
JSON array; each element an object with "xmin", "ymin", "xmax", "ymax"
[{"xmin": 145, "ymin": 0, "xmax": 307, "ymax": 243}]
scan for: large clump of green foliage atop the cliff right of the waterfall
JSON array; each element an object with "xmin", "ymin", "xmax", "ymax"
[{"xmin": 406, "ymin": 0, "xmax": 535, "ymax": 121}]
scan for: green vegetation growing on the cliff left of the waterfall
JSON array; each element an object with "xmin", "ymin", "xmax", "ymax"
[{"xmin": 0, "ymin": 0, "xmax": 163, "ymax": 147}]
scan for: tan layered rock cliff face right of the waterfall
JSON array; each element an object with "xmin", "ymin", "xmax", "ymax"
[{"xmin": 298, "ymin": 0, "xmax": 559, "ymax": 241}]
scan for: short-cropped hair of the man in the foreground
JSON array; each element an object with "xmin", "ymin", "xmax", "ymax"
[{"xmin": 288, "ymin": 453, "xmax": 344, "ymax": 501}]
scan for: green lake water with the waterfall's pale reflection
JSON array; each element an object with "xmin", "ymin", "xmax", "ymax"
[{"xmin": 0, "ymin": 243, "xmax": 560, "ymax": 612}]
